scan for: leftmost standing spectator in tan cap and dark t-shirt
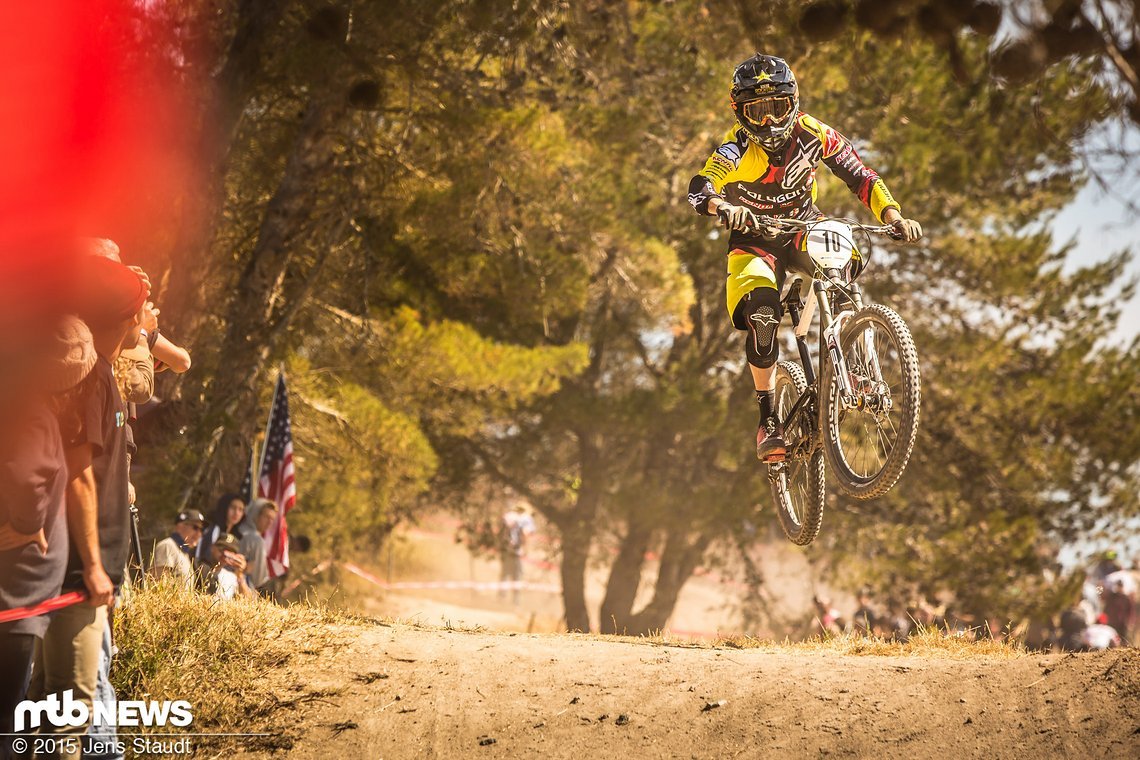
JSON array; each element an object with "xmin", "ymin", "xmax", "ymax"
[{"xmin": 0, "ymin": 317, "xmax": 96, "ymax": 758}]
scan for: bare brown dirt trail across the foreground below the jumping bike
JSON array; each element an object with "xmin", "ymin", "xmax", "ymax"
[{"xmin": 233, "ymin": 624, "xmax": 1140, "ymax": 760}]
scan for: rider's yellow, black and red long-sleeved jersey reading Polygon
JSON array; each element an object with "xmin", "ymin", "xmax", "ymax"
[{"xmin": 689, "ymin": 112, "xmax": 898, "ymax": 240}]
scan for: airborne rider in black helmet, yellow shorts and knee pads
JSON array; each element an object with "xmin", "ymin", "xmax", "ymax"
[{"xmin": 689, "ymin": 54, "xmax": 922, "ymax": 460}]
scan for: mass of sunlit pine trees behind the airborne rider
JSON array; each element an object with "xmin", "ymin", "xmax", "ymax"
[{"xmin": 133, "ymin": 0, "xmax": 1140, "ymax": 630}]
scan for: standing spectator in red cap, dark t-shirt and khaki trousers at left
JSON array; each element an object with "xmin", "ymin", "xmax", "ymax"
[{"xmin": 29, "ymin": 258, "xmax": 148, "ymax": 757}]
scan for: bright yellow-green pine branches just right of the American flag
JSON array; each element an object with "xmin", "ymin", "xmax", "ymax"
[{"xmin": 288, "ymin": 307, "xmax": 584, "ymax": 549}]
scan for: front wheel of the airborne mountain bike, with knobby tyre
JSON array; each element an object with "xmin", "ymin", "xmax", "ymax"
[{"xmin": 821, "ymin": 303, "xmax": 922, "ymax": 499}]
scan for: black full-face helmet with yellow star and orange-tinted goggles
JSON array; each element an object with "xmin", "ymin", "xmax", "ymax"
[{"xmin": 731, "ymin": 52, "xmax": 799, "ymax": 153}]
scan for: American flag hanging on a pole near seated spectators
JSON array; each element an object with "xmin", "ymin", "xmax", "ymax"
[{"xmin": 258, "ymin": 373, "xmax": 296, "ymax": 578}]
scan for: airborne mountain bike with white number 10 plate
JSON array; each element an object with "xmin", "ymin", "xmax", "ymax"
[{"xmin": 734, "ymin": 218, "xmax": 921, "ymax": 546}]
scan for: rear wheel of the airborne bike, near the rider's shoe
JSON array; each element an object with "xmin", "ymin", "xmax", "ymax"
[{"xmin": 768, "ymin": 361, "xmax": 825, "ymax": 546}]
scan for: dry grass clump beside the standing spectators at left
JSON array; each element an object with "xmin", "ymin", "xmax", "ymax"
[{"xmin": 112, "ymin": 582, "xmax": 364, "ymax": 749}]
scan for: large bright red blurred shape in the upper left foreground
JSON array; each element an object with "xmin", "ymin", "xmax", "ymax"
[{"xmin": 0, "ymin": 0, "xmax": 197, "ymax": 300}]
